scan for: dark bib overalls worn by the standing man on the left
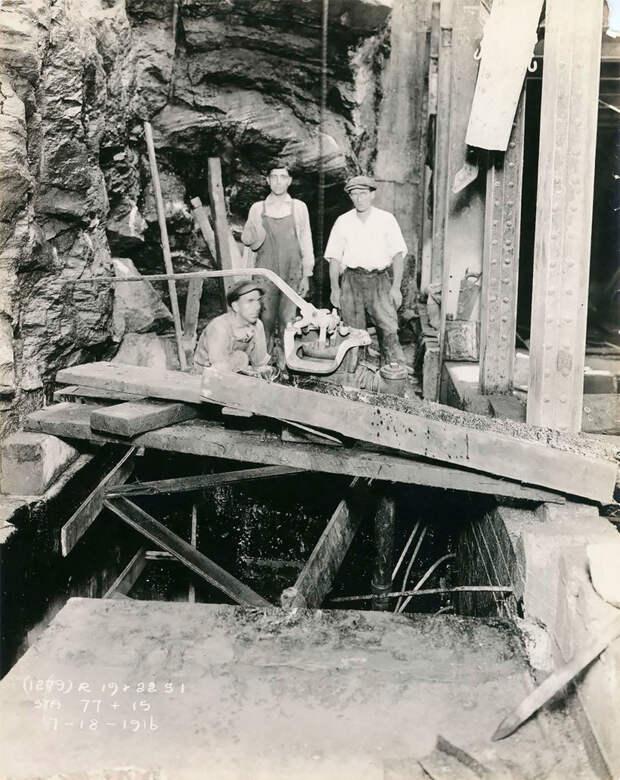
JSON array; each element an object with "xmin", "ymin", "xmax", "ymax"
[{"xmin": 256, "ymin": 206, "xmax": 302, "ymax": 352}]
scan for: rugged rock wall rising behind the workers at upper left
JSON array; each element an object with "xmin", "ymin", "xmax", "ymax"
[{"xmin": 0, "ymin": 0, "xmax": 400, "ymax": 436}]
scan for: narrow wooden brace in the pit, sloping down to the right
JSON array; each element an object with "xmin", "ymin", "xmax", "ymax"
[{"xmin": 104, "ymin": 497, "xmax": 270, "ymax": 607}]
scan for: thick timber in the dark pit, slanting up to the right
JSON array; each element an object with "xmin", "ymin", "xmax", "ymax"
[{"xmin": 281, "ymin": 477, "xmax": 366, "ymax": 609}]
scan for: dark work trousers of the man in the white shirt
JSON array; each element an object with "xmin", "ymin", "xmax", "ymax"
[{"xmin": 340, "ymin": 268, "xmax": 405, "ymax": 365}]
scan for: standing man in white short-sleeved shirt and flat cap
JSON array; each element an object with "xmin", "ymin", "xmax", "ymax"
[{"xmin": 325, "ymin": 176, "xmax": 407, "ymax": 365}]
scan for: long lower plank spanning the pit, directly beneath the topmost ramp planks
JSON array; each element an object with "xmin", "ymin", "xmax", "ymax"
[{"xmin": 25, "ymin": 403, "xmax": 564, "ymax": 503}]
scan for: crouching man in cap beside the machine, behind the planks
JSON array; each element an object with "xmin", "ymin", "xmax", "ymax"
[{"xmin": 194, "ymin": 281, "xmax": 275, "ymax": 379}]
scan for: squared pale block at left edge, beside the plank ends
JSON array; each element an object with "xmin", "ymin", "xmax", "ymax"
[{"xmin": 0, "ymin": 432, "xmax": 79, "ymax": 496}]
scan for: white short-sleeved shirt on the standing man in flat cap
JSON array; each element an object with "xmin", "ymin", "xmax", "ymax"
[{"xmin": 325, "ymin": 206, "xmax": 407, "ymax": 271}]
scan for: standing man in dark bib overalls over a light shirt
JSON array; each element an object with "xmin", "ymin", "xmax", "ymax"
[{"xmin": 241, "ymin": 162, "xmax": 314, "ymax": 360}]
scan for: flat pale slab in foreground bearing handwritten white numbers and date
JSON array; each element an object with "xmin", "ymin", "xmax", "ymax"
[{"xmin": 0, "ymin": 599, "xmax": 594, "ymax": 780}]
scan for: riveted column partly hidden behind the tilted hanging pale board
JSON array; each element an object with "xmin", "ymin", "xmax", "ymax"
[{"xmin": 480, "ymin": 89, "xmax": 525, "ymax": 393}]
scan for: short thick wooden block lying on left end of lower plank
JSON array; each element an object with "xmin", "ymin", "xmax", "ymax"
[{"xmin": 90, "ymin": 400, "xmax": 199, "ymax": 438}]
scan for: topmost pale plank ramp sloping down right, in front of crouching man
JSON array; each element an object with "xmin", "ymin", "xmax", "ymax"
[{"xmin": 52, "ymin": 363, "xmax": 617, "ymax": 503}]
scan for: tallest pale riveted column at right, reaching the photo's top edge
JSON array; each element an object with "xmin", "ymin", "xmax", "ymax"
[{"xmin": 527, "ymin": 0, "xmax": 603, "ymax": 431}]
